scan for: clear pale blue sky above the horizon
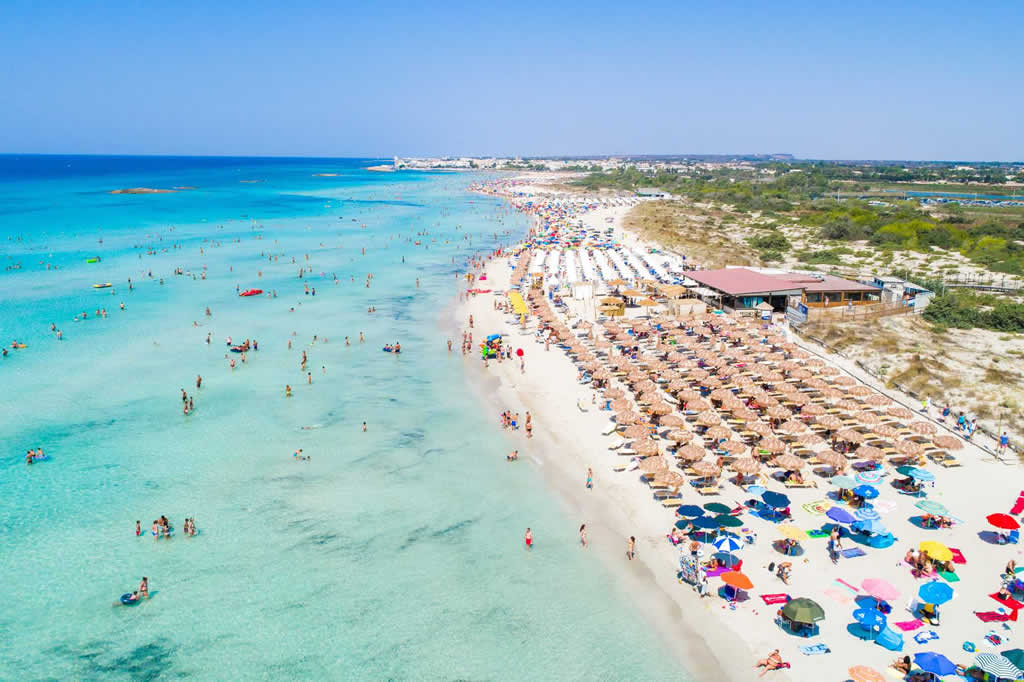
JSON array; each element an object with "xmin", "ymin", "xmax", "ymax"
[{"xmin": 0, "ymin": 0, "xmax": 1024, "ymax": 161}]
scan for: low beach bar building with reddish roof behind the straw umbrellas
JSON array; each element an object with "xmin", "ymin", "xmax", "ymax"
[{"xmin": 686, "ymin": 267, "xmax": 881, "ymax": 317}]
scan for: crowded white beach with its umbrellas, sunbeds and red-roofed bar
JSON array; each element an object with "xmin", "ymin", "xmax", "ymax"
[{"xmin": 459, "ymin": 171, "xmax": 1024, "ymax": 681}]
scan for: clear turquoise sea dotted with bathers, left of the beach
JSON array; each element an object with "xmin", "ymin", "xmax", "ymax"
[{"xmin": 0, "ymin": 156, "xmax": 684, "ymax": 680}]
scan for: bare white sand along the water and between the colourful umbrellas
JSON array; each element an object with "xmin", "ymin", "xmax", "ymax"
[{"xmin": 456, "ymin": 176, "xmax": 1024, "ymax": 680}]
